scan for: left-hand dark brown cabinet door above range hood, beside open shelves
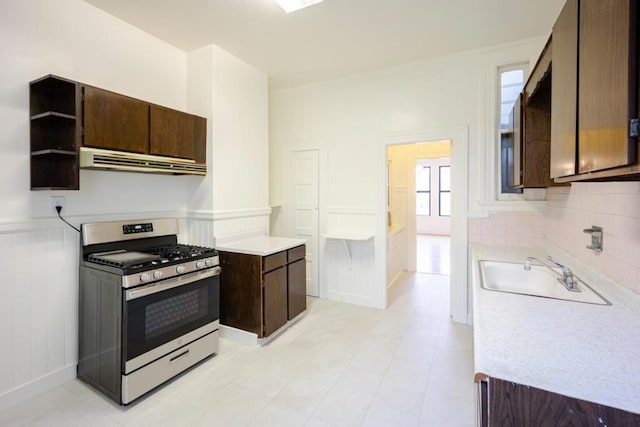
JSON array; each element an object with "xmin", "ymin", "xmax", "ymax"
[{"xmin": 83, "ymin": 86, "xmax": 149, "ymax": 154}]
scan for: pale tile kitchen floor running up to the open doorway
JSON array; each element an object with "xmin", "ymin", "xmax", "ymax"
[{"xmin": 0, "ymin": 273, "xmax": 475, "ymax": 427}]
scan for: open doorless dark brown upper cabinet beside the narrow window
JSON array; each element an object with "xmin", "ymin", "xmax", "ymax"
[{"xmin": 512, "ymin": 38, "xmax": 554, "ymax": 188}]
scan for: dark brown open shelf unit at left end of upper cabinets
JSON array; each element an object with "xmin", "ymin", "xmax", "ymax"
[{"xmin": 29, "ymin": 75, "xmax": 81, "ymax": 190}]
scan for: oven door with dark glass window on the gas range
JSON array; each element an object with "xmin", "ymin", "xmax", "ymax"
[{"xmin": 122, "ymin": 267, "xmax": 221, "ymax": 374}]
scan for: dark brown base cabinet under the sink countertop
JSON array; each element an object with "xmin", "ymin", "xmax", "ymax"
[{"xmin": 476, "ymin": 374, "xmax": 640, "ymax": 427}]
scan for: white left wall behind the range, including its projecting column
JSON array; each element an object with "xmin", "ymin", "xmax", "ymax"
[{"xmin": 0, "ymin": 0, "xmax": 269, "ymax": 411}]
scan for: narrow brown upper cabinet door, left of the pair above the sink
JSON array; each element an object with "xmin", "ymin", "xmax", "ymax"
[{"xmin": 550, "ymin": 0, "xmax": 578, "ymax": 178}]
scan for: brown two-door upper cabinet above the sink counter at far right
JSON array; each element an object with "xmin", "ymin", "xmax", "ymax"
[{"xmin": 551, "ymin": 0, "xmax": 640, "ymax": 182}]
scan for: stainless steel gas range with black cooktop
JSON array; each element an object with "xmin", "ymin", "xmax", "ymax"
[{"xmin": 78, "ymin": 218, "xmax": 220, "ymax": 405}]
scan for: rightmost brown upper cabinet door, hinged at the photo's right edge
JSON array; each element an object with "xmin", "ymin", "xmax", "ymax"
[{"xmin": 576, "ymin": 0, "xmax": 637, "ymax": 173}]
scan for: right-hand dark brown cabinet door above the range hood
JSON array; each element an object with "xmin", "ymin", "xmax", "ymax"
[{"xmin": 149, "ymin": 105, "xmax": 196, "ymax": 160}]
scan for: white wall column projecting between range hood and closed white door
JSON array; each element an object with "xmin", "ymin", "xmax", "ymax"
[{"xmin": 187, "ymin": 45, "xmax": 270, "ymax": 246}]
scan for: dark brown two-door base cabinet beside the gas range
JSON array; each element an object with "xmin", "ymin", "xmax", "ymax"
[{"xmin": 219, "ymin": 245, "xmax": 307, "ymax": 338}]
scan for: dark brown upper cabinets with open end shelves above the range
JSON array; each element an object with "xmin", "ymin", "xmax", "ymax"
[{"xmin": 29, "ymin": 75, "xmax": 207, "ymax": 190}]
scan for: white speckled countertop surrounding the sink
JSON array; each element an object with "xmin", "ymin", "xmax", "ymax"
[{"xmin": 471, "ymin": 245, "xmax": 640, "ymax": 413}]
